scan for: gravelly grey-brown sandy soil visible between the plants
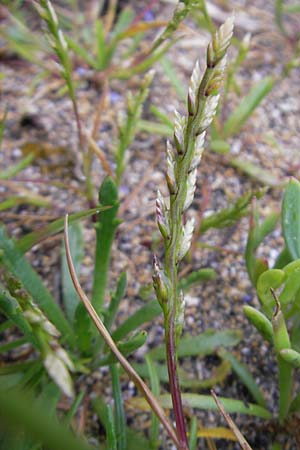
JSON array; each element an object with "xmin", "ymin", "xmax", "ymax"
[{"xmin": 0, "ymin": 0, "xmax": 300, "ymax": 450}]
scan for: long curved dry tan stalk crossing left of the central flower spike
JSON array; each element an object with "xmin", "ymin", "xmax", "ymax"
[{"xmin": 64, "ymin": 214, "xmax": 179, "ymax": 447}]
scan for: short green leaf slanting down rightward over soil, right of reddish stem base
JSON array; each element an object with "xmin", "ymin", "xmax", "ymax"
[{"xmin": 218, "ymin": 350, "xmax": 266, "ymax": 408}]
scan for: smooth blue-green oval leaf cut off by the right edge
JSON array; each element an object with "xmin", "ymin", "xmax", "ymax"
[{"xmin": 282, "ymin": 178, "xmax": 300, "ymax": 259}]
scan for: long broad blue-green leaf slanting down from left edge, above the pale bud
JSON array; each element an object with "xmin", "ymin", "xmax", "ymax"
[{"xmin": 0, "ymin": 227, "xmax": 74, "ymax": 345}]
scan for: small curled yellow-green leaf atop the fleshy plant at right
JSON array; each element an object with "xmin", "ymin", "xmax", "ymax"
[{"xmin": 257, "ymin": 269, "xmax": 286, "ymax": 318}]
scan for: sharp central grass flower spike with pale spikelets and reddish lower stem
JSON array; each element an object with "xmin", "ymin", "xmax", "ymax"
[{"xmin": 153, "ymin": 19, "xmax": 233, "ymax": 450}]
